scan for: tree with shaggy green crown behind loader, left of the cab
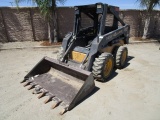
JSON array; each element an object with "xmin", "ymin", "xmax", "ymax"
[{"xmin": 15, "ymin": 0, "xmax": 66, "ymax": 43}]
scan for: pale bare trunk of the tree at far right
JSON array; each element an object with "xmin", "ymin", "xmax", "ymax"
[{"xmin": 142, "ymin": 15, "xmax": 151, "ymax": 39}]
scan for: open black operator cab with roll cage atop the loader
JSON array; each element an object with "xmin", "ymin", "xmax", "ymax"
[{"xmin": 73, "ymin": 3, "xmax": 119, "ymax": 47}]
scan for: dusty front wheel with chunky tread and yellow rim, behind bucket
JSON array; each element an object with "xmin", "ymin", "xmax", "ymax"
[{"xmin": 92, "ymin": 53, "xmax": 114, "ymax": 82}]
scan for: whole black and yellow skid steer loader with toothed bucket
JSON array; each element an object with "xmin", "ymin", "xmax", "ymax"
[{"xmin": 22, "ymin": 3, "xmax": 130, "ymax": 114}]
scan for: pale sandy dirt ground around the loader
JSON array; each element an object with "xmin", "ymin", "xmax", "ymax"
[{"xmin": 0, "ymin": 43, "xmax": 160, "ymax": 120}]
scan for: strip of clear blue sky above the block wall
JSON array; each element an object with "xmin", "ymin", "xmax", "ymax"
[{"xmin": 0, "ymin": 0, "xmax": 160, "ymax": 10}]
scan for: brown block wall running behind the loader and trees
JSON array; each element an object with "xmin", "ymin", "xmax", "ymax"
[{"xmin": 0, "ymin": 7, "xmax": 160, "ymax": 42}]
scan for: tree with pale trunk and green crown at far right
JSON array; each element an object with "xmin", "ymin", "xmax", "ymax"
[{"xmin": 137, "ymin": 0, "xmax": 160, "ymax": 39}]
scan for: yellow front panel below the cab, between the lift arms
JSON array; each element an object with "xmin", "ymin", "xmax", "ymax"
[{"xmin": 71, "ymin": 51, "xmax": 86, "ymax": 62}]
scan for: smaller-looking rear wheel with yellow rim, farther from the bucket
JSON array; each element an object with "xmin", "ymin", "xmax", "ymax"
[{"xmin": 115, "ymin": 46, "xmax": 128, "ymax": 69}]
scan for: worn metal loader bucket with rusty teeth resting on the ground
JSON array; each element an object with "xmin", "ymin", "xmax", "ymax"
[{"xmin": 22, "ymin": 57, "xmax": 95, "ymax": 114}]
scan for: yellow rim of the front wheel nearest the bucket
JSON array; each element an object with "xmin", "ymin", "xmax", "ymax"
[{"xmin": 104, "ymin": 59, "xmax": 113, "ymax": 77}]
